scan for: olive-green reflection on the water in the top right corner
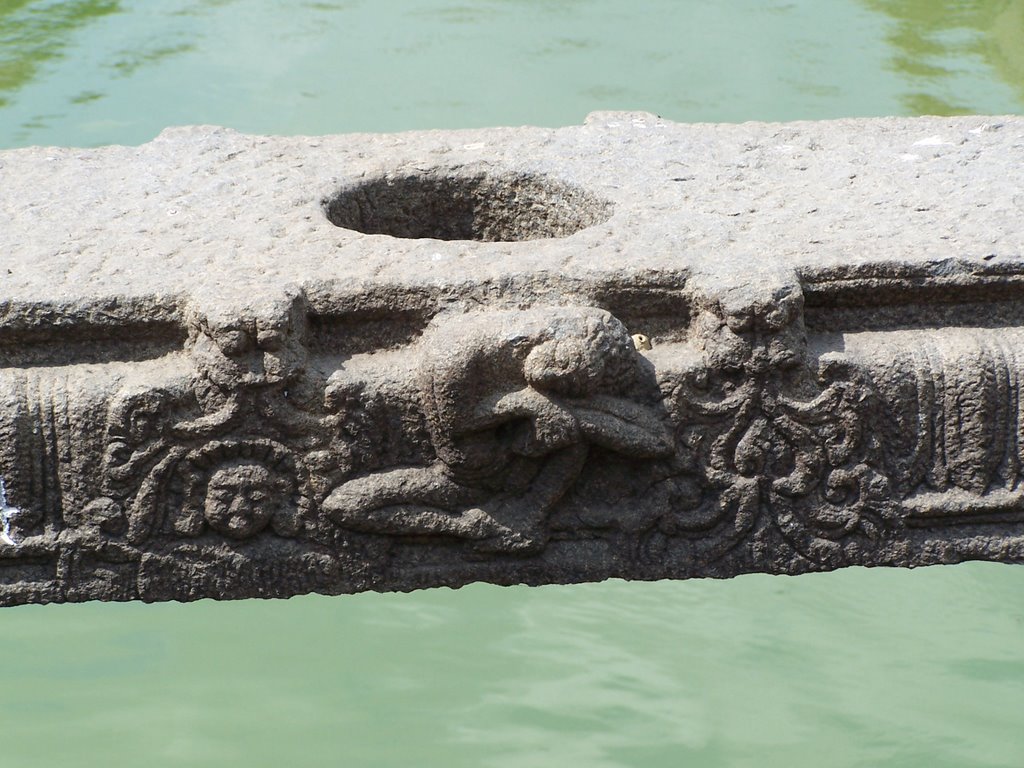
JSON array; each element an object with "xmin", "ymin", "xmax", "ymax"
[{"xmin": 864, "ymin": 0, "xmax": 1024, "ymax": 115}]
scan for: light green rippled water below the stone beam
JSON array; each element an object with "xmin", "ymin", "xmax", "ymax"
[{"xmin": 0, "ymin": 563, "xmax": 1024, "ymax": 768}]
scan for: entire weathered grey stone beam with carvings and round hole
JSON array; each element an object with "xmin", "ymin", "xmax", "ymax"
[{"xmin": 0, "ymin": 113, "xmax": 1024, "ymax": 604}]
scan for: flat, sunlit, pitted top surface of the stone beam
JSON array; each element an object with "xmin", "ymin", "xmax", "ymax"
[{"xmin": 0, "ymin": 113, "xmax": 1024, "ymax": 309}]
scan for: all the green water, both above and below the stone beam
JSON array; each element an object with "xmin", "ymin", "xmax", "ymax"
[{"xmin": 0, "ymin": 0, "xmax": 1024, "ymax": 768}]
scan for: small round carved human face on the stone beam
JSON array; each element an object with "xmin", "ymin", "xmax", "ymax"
[{"xmin": 204, "ymin": 461, "xmax": 285, "ymax": 539}]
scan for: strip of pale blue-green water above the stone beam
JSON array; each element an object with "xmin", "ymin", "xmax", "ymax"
[{"xmin": 0, "ymin": 0, "xmax": 1024, "ymax": 146}]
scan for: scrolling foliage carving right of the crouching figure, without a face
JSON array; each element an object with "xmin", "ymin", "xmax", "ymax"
[{"xmin": 666, "ymin": 280, "xmax": 899, "ymax": 563}]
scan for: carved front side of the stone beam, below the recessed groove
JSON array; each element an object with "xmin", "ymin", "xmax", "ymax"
[{"xmin": 0, "ymin": 269, "xmax": 1024, "ymax": 603}]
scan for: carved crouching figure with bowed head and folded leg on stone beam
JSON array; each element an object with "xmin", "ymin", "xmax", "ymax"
[{"xmin": 324, "ymin": 307, "xmax": 673, "ymax": 551}]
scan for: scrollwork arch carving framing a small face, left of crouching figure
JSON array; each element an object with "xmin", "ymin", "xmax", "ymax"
[{"xmin": 86, "ymin": 286, "xmax": 328, "ymax": 545}]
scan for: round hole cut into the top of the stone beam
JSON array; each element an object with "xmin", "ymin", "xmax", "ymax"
[{"xmin": 326, "ymin": 172, "xmax": 611, "ymax": 243}]
